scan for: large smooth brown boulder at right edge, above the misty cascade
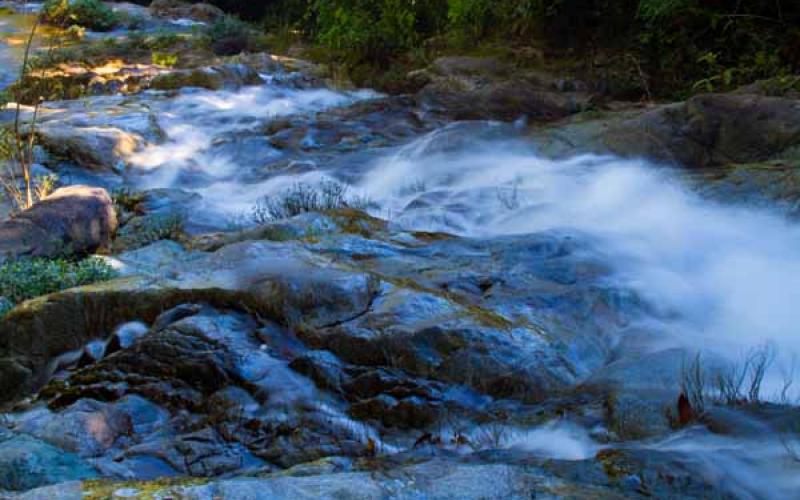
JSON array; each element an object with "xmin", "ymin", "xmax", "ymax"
[{"xmin": 537, "ymin": 93, "xmax": 800, "ymax": 167}]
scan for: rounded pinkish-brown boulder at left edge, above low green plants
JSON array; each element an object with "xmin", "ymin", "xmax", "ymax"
[{"xmin": 0, "ymin": 186, "xmax": 117, "ymax": 262}]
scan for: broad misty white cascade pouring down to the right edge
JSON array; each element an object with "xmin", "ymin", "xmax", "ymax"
[{"xmin": 360, "ymin": 131, "xmax": 800, "ymax": 390}]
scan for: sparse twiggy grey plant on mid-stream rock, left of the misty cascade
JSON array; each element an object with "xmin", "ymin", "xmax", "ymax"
[{"xmin": 252, "ymin": 181, "xmax": 371, "ymax": 224}]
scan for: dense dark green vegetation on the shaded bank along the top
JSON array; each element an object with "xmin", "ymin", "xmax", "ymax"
[{"xmin": 183, "ymin": 0, "xmax": 800, "ymax": 95}]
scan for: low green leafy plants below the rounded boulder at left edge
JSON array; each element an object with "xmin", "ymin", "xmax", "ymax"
[{"xmin": 0, "ymin": 257, "xmax": 116, "ymax": 314}]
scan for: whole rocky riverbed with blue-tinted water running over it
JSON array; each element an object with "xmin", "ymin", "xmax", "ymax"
[{"xmin": 0, "ymin": 1, "xmax": 800, "ymax": 499}]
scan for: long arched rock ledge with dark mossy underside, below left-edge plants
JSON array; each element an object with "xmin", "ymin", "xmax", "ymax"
[{"xmin": 0, "ymin": 236, "xmax": 377, "ymax": 404}]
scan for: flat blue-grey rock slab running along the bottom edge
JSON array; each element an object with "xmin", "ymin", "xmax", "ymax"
[{"xmin": 18, "ymin": 450, "xmax": 744, "ymax": 500}]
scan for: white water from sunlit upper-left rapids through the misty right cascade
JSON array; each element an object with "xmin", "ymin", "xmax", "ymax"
[{"xmin": 119, "ymin": 77, "xmax": 800, "ymax": 390}]
